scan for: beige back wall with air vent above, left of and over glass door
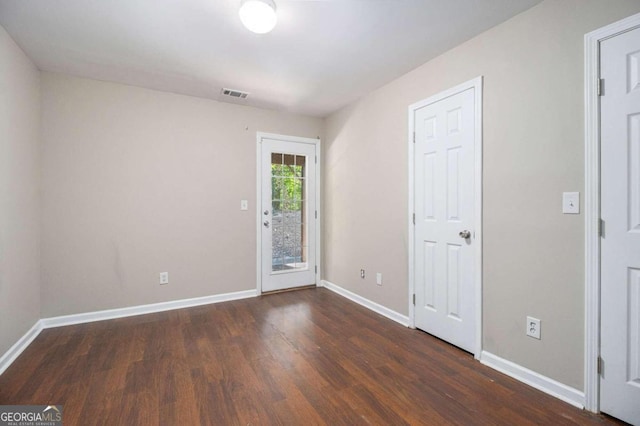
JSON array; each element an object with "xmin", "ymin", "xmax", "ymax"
[{"xmin": 42, "ymin": 73, "xmax": 323, "ymax": 317}]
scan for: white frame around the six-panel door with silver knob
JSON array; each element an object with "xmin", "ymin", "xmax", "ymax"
[{"xmin": 407, "ymin": 76, "xmax": 483, "ymax": 360}]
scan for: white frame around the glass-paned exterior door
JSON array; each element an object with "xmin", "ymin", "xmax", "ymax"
[{"xmin": 256, "ymin": 132, "xmax": 322, "ymax": 295}]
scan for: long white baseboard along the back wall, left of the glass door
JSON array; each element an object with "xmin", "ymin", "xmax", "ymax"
[{"xmin": 41, "ymin": 290, "xmax": 258, "ymax": 328}]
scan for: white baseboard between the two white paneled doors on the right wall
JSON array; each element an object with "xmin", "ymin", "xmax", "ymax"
[{"xmin": 480, "ymin": 351, "xmax": 585, "ymax": 409}]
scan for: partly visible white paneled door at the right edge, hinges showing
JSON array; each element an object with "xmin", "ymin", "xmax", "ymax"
[{"xmin": 600, "ymin": 25, "xmax": 640, "ymax": 425}]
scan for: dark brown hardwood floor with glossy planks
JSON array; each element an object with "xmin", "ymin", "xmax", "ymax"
[{"xmin": 0, "ymin": 289, "xmax": 615, "ymax": 426}]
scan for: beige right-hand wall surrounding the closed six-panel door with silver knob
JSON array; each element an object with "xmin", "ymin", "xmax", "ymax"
[{"xmin": 324, "ymin": 0, "xmax": 640, "ymax": 389}]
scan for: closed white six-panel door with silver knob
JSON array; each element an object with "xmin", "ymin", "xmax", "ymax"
[{"xmin": 413, "ymin": 87, "xmax": 479, "ymax": 353}]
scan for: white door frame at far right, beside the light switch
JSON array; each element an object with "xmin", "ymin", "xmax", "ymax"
[{"xmin": 584, "ymin": 13, "xmax": 640, "ymax": 413}]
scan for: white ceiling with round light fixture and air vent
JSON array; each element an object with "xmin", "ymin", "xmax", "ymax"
[{"xmin": 0, "ymin": 0, "xmax": 541, "ymax": 116}]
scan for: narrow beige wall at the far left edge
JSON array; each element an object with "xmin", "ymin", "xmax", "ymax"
[{"xmin": 0, "ymin": 27, "xmax": 40, "ymax": 356}]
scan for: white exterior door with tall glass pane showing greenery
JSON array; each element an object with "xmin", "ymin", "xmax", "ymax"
[{"xmin": 259, "ymin": 135, "xmax": 318, "ymax": 292}]
